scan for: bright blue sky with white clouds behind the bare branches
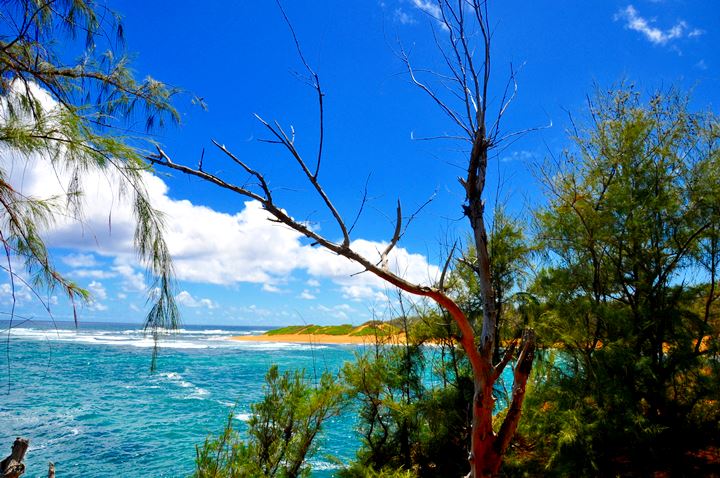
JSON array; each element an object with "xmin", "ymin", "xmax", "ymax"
[{"xmin": 0, "ymin": 0, "xmax": 720, "ymax": 325}]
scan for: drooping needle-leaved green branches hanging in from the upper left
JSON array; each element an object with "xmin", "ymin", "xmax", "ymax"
[{"xmin": 0, "ymin": 0, "xmax": 179, "ymax": 358}]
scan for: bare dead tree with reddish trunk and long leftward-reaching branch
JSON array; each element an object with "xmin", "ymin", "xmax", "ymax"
[{"xmin": 147, "ymin": 0, "xmax": 535, "ymax": 478}]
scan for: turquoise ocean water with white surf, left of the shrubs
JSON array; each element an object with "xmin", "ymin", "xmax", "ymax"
[{"xmin": 0, "ymin": 322, "xmax": 359, "ymax": 478}]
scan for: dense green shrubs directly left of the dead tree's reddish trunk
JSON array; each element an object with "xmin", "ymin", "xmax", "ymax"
[{"xmin": 341, "ymin": 315, "xmax": 473, "ymax": 477}]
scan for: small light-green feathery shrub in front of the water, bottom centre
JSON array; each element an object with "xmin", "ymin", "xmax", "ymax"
[{"xmin": 194, "ymin": 366, "xmax": 343, "ymax": 478}]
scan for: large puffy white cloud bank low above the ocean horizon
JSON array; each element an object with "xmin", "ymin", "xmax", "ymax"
[{"xmin": 0, "ymin": 83, "xmax": 438, "ymax": 299}]
